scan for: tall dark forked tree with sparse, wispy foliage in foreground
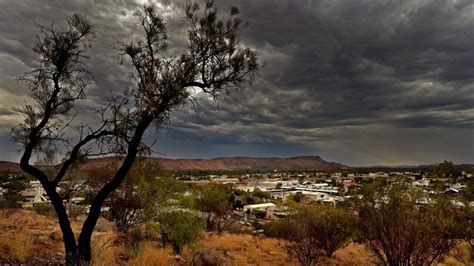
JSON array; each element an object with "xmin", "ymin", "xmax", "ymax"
[{"xmin": 12, "ymin": 2, "xmax": 258, "ymax": 265}]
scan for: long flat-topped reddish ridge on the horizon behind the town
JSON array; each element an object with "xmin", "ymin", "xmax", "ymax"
[{"xmin": 0, "ymin": 156, "xmax": 349, "ymax": 172}]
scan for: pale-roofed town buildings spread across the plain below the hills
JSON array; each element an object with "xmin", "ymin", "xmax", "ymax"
[{"xmin": 0, "ymin": 168, "xmax": 474, "ymax": 222}]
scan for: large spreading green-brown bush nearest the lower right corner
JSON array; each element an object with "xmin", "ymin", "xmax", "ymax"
[{"xmin": 358, "ymin": 184, "xmax": 460, "ymax": 265}]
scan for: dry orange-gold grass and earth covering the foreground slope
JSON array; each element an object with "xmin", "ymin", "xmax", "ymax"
[{"xmin": 0, "ymin": 210, "xmax": 468, "ymax": 265}]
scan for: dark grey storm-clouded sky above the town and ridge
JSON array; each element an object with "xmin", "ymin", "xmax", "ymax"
[{"xmin": 0, "ymin": 0, "xmax": 474, "ymax": 166}]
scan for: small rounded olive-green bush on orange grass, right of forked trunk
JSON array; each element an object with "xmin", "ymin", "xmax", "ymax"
[{"xmin": 159, "ymin": 209, "xmax": 205, "ymax": 254}]
